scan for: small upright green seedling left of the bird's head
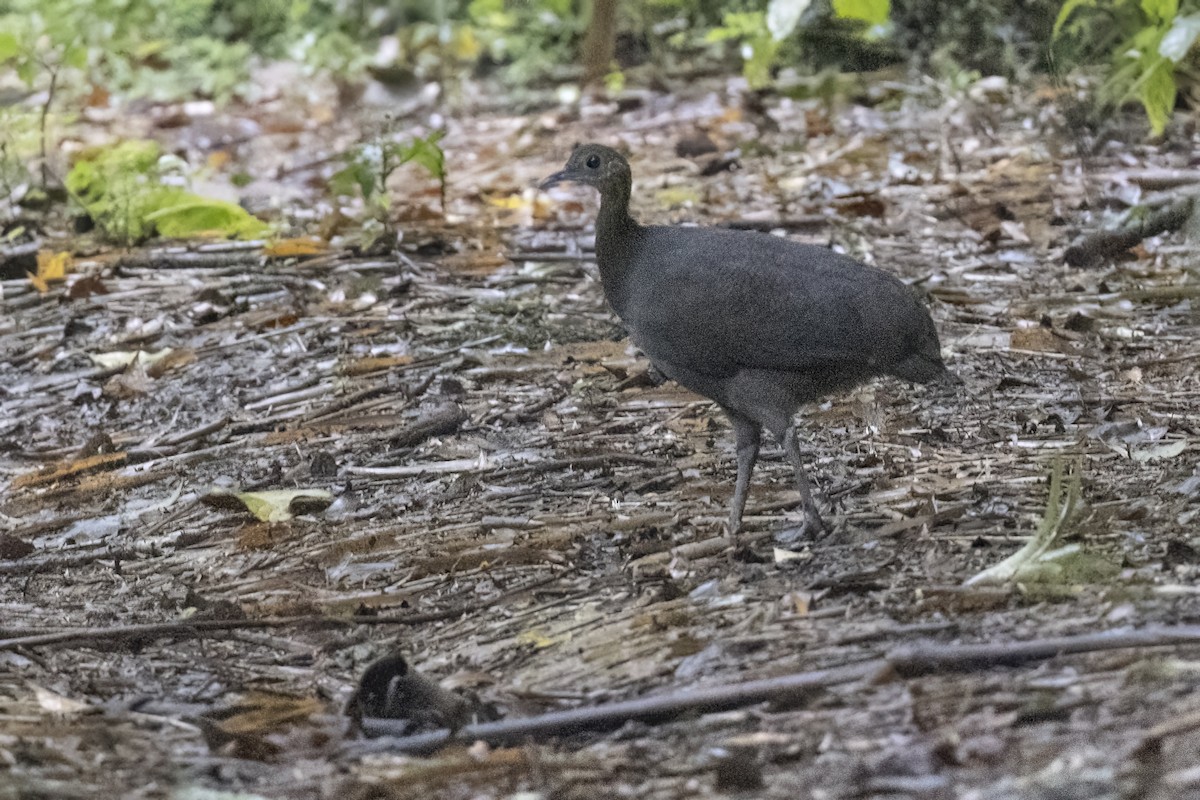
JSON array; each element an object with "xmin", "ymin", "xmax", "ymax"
[{"xmin": 330, "ymin": 122, "xmax": 446, "ymax": 230}]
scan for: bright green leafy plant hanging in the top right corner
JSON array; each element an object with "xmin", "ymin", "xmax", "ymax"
[{"xmin": 1054, "ymin": 0, "xmax": 1200, "ymax": 136}]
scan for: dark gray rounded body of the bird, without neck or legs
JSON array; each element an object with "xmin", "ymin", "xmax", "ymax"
[{"xmin": 598, "ymin": 227, "xmax": 944, "ymax": 383}]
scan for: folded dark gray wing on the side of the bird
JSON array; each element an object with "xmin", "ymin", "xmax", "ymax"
[{"xmin": 628, "ymin": 229, "xmax": 924, "ymax": 374}]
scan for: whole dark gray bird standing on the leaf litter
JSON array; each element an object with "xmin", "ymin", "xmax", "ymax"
[{"xmin": 541, "ymin": 144, "xmax": 948, "ymax": 535}]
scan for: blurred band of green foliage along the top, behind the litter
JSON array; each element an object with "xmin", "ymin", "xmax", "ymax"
[{"xmin": 0, "ymin": 0, "xmax": 1200, "ymax": 227}]
